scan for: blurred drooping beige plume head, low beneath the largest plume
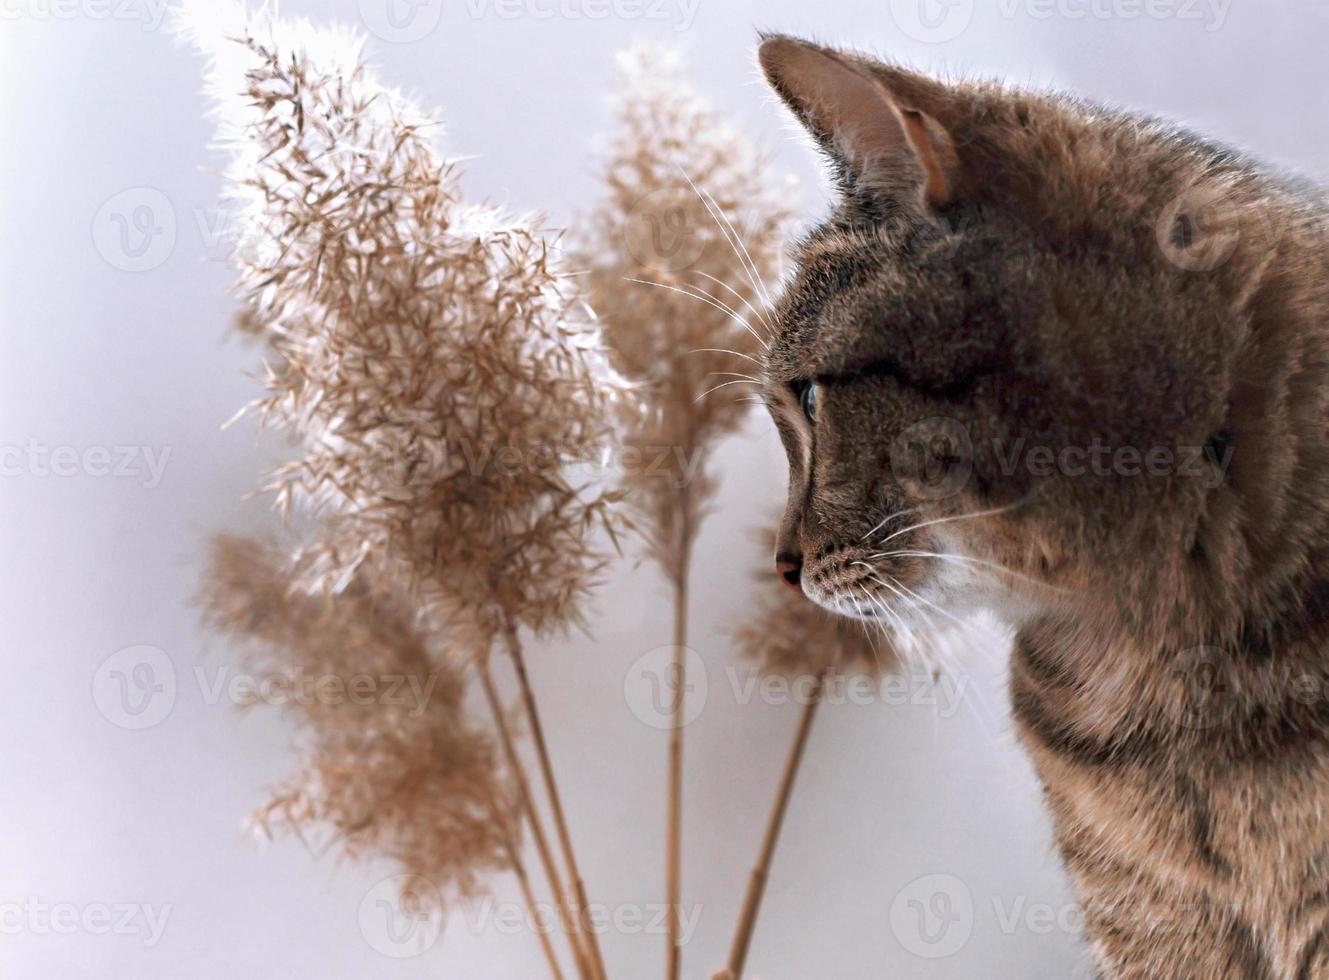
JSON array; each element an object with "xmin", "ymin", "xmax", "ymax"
[{"xmin": 202, "ymin": 536, "xmax": 518, "ymax": 895}]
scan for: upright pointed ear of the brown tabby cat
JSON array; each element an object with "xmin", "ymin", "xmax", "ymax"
[{"xmin": 758, "ymin": 36, "xmax": 958, "ymax": 209}]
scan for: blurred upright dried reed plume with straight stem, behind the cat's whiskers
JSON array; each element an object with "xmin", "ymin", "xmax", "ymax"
[{"xmin": 577, "ymin": 47, "xmax": 788, "ymax": 980}]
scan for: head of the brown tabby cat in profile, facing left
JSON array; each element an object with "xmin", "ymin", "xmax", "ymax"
[{"xmin": 759, "ymin": 36, "xmax": 1297, "ymax": 643}]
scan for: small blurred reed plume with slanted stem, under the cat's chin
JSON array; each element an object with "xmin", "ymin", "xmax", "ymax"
[{"xmin": 714, "ymin": 523, "xmax": 900, "ymax": 980}]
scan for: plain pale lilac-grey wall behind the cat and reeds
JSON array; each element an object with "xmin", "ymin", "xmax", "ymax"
[{"xmin": 0, "ymin": 0, "xmax": 1329, "ymax": 980}]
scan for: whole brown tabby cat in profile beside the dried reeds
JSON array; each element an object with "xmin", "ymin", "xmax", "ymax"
[{"xmin": 760, "ymin": 36, "xmax": 1329, "ymax": 980}]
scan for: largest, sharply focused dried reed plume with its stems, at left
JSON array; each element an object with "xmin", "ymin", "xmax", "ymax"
[{"xmin": 183, "ymin": 0, "xmax": 623, "ymax": 977}]
